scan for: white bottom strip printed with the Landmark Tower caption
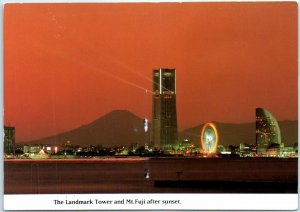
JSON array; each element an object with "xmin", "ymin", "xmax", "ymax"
[{"xmin": 4, "ymin": 194, "xmax": 298, "ymax": 210}]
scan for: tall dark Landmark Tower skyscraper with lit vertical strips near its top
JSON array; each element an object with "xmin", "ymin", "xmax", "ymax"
[{"xmin": 152, "ymin": 68, "xmax": 178, "ymax": 150}]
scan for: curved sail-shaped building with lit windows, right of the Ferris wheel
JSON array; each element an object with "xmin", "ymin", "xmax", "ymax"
[{"xmin": 256, "ymin": 108, "xmax": 281, "ymax": 156}]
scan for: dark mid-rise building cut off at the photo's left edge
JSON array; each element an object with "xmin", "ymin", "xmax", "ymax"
[{"xmin": 3, "ymin": 126, "xmax": 15, "ymax": 157}]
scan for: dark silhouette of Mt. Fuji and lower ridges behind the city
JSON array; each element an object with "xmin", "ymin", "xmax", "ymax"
[{"xmin": 21, "ymin": 110, "xmax": 298, "ymax": 147}]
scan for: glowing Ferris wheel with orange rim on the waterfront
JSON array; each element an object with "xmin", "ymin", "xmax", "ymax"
[{"xmin": 200, "ymin": 122, "xmax": 219, "ymax": 154}]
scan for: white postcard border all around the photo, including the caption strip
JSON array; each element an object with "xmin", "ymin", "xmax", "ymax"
[{"xmin": 0, "ymin": 0, "xmax": 300, "ymax": 210}]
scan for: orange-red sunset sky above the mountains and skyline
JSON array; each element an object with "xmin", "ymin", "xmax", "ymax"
[{"xmin": 4, "ymin": 2, "xmax": 298, "ymax": 141}]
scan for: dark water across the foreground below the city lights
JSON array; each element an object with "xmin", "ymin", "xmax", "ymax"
[{"xmin": 4, "ymin": 158, "xmax": 298, "ymax": 194}]
